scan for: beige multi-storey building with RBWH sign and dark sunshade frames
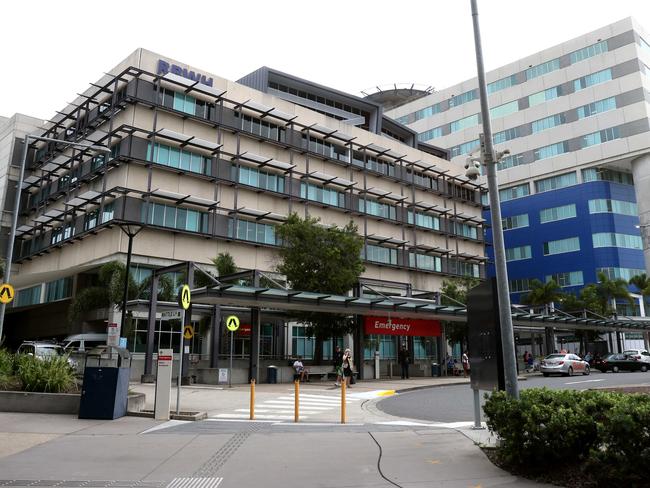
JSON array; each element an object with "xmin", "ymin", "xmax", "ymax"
[{"xmin": 2, "ymin": 49, "xmax": 485, "ymax": 378}]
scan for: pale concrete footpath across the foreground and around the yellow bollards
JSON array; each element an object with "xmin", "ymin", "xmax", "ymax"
[{"xmin": 0, "ymin": 378, "xmax": 544, "ymax": 488}]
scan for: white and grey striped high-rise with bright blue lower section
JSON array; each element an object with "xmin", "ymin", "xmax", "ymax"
[{"xmin": 388, "ymin": 18, "xmax": 650, "ymax": 328}]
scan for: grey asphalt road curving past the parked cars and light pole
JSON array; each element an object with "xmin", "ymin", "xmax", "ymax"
[{"xmin": 377, "ymin": 370, "xmax": 650, "ymax": 422}]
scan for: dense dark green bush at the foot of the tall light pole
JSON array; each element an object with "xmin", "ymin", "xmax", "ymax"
[{"xmin": 483, "ymin": 389, "xmax": 650, "ymax": 486}]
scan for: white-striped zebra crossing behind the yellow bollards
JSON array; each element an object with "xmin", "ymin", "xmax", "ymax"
[{"xmin": 210, "ymin": 393, "xmax": 361, "ymax": 421}]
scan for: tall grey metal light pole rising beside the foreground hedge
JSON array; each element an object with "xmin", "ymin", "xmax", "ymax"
[{"xmin": 470, "ymin": 0, "xmax": 519, "ymax": 398}]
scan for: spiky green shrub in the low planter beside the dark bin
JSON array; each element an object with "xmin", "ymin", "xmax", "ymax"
[{"xmin": 17, "ymin": 355, "xmax": 76, "ymax": 393}]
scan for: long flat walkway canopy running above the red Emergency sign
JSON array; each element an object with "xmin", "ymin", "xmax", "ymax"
[{"xmin": 192, "ymin": 284, "xmax": 650, "ymax": 332}]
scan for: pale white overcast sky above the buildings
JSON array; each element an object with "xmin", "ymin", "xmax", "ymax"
[{"xmin": 0, "ymin": 0, "xmax": 650, "ymax": 119}]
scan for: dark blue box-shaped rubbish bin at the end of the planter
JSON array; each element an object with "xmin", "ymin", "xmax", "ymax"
[{"xmin": 79, "ymin": 346, "xmax": 131, "ymax": 420}]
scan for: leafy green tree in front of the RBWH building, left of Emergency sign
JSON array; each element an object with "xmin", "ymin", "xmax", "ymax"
[{"xmin": 277, "ymin": 213, "xmax": 364, "ymax": 344}]
